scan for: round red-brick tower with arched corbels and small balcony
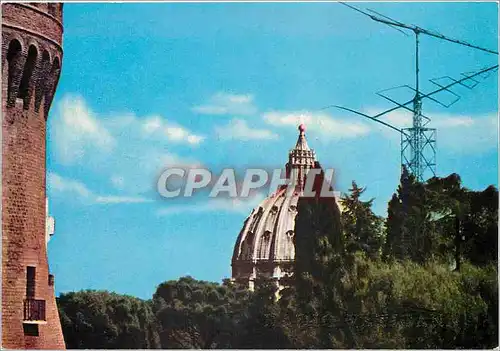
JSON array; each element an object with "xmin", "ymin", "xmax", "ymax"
[{"xmin": 1, "ymin": 3, "xmax": 65, "ymax": 349}]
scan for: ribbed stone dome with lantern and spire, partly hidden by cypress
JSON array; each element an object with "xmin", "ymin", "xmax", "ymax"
[{"xmin": 232, "ymin": 125, "xmax": 316, "ymax": 288}]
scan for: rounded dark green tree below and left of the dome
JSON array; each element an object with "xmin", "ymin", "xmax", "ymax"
[{"xmin": 153, "ymin": 277, "xmax": 248, "ymax": 348}]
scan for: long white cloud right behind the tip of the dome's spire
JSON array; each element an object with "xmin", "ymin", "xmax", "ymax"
[{"xmin": 263, "ymin": 111, "xmax": 370, "ymax": 138}]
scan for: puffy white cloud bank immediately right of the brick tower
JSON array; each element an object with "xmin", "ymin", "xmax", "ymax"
[{"xmin": 51, "ymin": 95, "xmax": 205, "ymax": 164}]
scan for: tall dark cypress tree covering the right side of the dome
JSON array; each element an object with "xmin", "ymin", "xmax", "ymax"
[{"xmin": 294, "ymin": 163, "xmax": 356, "ymax": 348}]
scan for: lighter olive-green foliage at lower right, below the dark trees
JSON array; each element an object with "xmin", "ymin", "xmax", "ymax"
[{"xmin": 283, "ymin": 252, "xmax": 498, "ymax": 349}]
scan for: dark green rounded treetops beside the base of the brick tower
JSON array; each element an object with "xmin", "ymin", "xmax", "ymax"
[{"xmin": 57, "ymin": 290, "xmax": 159, "ymax": 349}]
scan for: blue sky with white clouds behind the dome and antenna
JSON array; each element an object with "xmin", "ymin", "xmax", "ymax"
[{"xmin": 47, "ymin": 3, "xmax": 498, "ymax": 298}]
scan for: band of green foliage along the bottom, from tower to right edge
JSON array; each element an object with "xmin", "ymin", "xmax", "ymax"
[{"xmin": 58, "ymin": 264, "xmax": 498, "ymax": 349}]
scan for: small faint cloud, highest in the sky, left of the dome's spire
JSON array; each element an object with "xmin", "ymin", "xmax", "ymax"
[{"xmin": 192, "ymin": 92, "xmax": 257, "ymax": 115}]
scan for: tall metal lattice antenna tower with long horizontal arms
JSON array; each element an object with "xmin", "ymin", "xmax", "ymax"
[{"xmin": 322, "ymin": 2, "xmax": 498, "ymax": 181}]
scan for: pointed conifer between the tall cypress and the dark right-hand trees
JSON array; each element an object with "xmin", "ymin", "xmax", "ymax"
[{"xmin": 342, "ymin": 181, "xmax": 383, "ymax": 258}]
